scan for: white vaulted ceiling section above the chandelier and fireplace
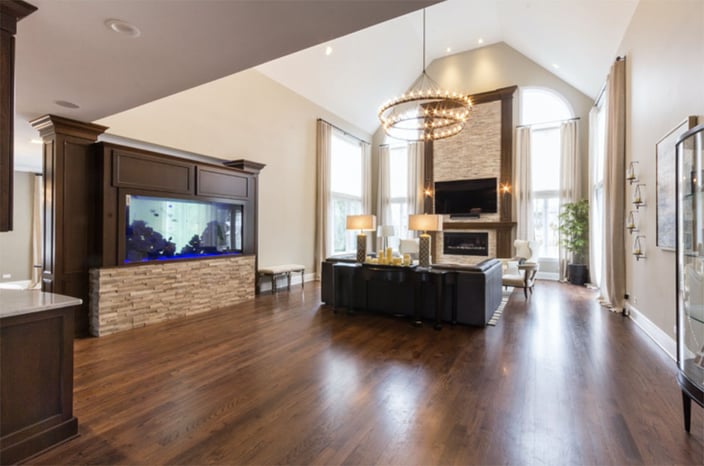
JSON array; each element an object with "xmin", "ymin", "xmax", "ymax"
[{"xmin": 257, "ymin": 0, "xmax": 638, "ymax": 133}]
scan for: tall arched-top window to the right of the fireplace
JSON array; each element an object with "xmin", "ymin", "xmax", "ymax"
[{"xmin": 520, "ymin": 88, "xmax": 574, "ymax": 262}]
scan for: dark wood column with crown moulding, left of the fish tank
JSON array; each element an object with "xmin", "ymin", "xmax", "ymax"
[{"xmin": 30, "ymin": 115, "xmax": 107, "ymax": 336}]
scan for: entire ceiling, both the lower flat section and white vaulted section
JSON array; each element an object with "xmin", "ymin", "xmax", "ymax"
[{"xmin": 15, "ymin": 0, "xmax": 640, "ymax": 169}]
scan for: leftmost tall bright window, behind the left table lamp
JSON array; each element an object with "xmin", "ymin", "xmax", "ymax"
[{"xmin": 330, "ymin": 130, "xmax": 365, "ymax": 254}]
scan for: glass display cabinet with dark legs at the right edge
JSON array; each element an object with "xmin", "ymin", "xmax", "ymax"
[{"xmin": 677, "ymin": 125, "xmax": 704, "ymax": 432}]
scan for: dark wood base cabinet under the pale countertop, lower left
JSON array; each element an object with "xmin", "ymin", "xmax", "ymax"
[{"xmin": 0, "ymin": 291, "xmax": 78, "ymax": 464}]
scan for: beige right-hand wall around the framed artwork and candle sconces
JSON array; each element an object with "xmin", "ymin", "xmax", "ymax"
[{"xmin": 619, "ymin": 0, "xmax": 704, "ymax": 338}]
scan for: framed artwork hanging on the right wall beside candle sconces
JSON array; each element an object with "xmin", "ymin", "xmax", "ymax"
[{"xmin": 655, "ymin": 116, "xmax": 697, "ymax": 251}]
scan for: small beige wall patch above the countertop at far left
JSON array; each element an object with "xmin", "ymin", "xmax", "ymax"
[{"xmin": 0, "ymin": 171, "xmax": 35, "ymax": 282}]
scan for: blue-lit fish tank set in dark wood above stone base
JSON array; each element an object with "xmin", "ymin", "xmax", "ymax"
[{"xmin": 124, "ymin": 194, "xmax": 243, "ymax": 264}]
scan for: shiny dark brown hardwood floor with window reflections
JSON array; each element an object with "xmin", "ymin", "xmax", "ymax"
[{"xmin": 31, "ymin": 281, "xmax": 704, "ymax": 465}]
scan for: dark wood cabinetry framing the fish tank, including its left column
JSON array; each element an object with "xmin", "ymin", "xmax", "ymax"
[{"xmin": 31, "ymin": 115, "xmax": 264, "ymax": 336}]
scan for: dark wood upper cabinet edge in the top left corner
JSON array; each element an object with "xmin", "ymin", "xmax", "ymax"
[{"xmin": 0, "ymin": 0, "xmax": 37, "ymax": 231}]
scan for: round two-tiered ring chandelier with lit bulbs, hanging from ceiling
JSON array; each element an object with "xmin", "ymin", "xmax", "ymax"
[{"xmin": 378, "ymin": 9, "xmax": 472, "ymax": 141}]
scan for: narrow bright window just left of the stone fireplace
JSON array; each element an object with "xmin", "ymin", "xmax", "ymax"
[{"xmin": 384, "ymin": 146, "xmax": 410, "ymax": 249}]
